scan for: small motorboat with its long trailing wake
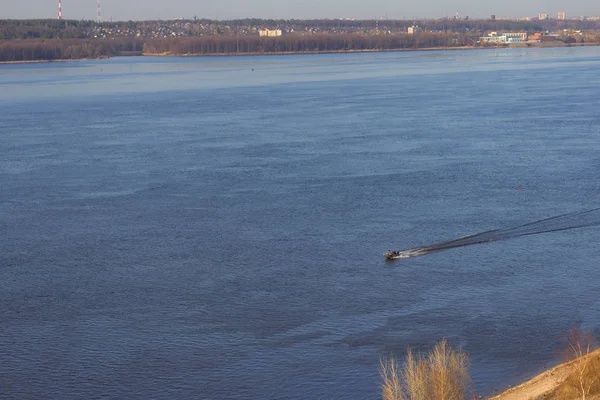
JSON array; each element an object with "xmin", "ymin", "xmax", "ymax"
[{"xmin": 384, "ymin": 208, "xmax": 600, "ymax": 260}]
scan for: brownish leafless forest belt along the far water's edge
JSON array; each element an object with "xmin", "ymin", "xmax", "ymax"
[{"xmin": 0, "ymin": 32, "xmax": 600, "ymax": 62}]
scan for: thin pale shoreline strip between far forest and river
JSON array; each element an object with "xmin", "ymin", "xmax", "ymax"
[{"xmin": 0, "ymin": 42, "xmax": 600, "ymax": 64}]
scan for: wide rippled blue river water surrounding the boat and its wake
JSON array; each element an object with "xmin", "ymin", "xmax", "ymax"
[{"xmin": 0, "ymin": 47, "xmax": 600, "ymax": 399}]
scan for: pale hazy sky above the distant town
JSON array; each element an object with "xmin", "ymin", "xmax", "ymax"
[{"xmin": 0, "ymin": 0, "xmax": 600, "ymax": 20}]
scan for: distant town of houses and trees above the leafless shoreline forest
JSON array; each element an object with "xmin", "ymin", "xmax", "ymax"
[{"xmin": 0, "ymin": 11, "xmax": 600, "ymax": 43}]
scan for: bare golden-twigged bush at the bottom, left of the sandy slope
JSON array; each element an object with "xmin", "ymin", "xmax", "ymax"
[{"xmin": 380, "ymin": 340, "xmax": 470, "ymax": 400}]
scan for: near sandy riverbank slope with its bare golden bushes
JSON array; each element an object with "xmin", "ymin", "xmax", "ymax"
[{"xmin": 380, "ymin": 329, "xmax": 600, "ymax": 400}]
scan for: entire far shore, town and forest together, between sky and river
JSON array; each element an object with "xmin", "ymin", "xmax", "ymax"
[{"xmin": 0, "ymin": 12, "xmax": 600, "ymax": 62}]
